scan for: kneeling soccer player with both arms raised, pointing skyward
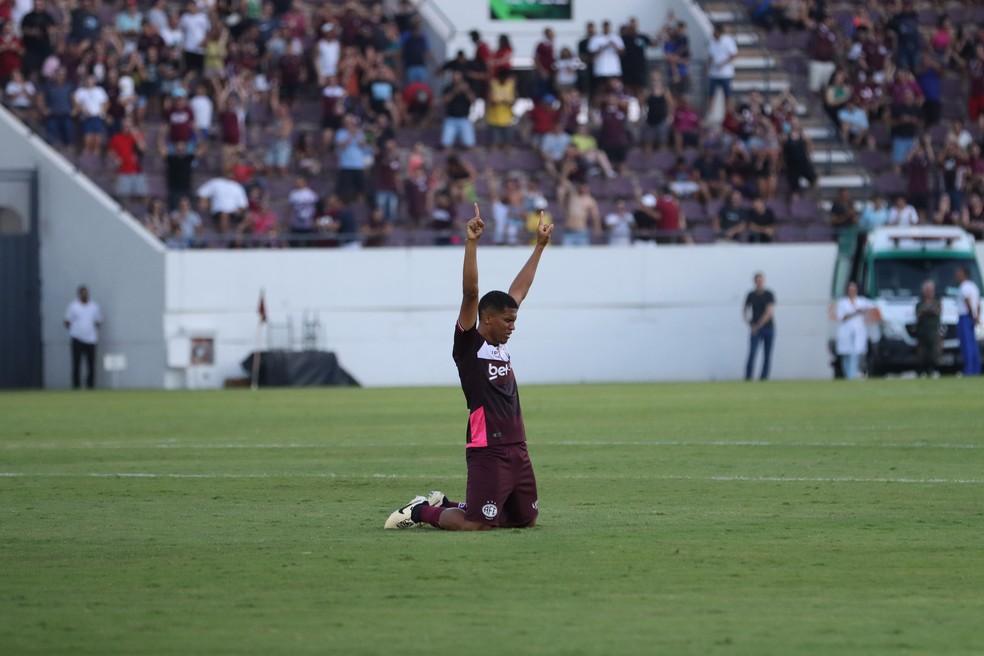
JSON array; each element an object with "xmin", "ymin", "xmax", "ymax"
[{"xmin": 384, "ymin": 203, "xmax": 553, "ymax": 531}]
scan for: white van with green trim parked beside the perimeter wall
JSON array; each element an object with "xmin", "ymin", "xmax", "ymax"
[{"xmin": 830, "ymin": 226, "xmax": 984, "ymax": 377}]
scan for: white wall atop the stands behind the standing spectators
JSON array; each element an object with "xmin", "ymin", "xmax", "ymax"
[{"xmin": 419, "ymin": 0, "xmax": 711, "ymax": 64}]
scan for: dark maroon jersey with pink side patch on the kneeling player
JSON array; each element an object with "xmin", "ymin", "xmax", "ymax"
[{"xmin": 451, "ymin": 324, "xmax": 526, "ymax": 448}]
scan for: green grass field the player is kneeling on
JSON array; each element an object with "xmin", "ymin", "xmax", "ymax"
[{"xmin": 0, "ymin": 379, "xmax": 984, "ymax": 656}]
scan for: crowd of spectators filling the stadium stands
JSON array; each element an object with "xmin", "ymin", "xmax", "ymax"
[{"xmin": 0, "ymin": 0, "xmax": 984, "ymax": 247}]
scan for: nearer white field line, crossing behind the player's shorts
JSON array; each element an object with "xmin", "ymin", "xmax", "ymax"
[{"xmin": 0, "ymin": 472, "xmax": 984, "ymax": 485}]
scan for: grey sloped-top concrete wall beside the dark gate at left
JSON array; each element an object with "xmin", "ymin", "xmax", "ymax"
[{"xmin": 0, "ymin": 108, "xmax": 164, "ymax": 388}]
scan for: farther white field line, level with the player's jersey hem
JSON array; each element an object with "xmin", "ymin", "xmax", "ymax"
[{"xmin": 0, "ymin": 440, "xmax": 984, "ymax": 450}]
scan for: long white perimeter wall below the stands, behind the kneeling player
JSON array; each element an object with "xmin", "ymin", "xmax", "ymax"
[{"xmin": 165, "ymin": 244, "xmax": 835, "ymax": 386}]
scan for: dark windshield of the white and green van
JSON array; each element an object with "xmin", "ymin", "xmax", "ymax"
[{"xmin": 871, "ymin": 257, "xmax": 981, "ymax": 298}]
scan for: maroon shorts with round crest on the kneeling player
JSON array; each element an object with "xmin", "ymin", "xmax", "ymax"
[{"xmin": 465, "ymin": 442, "xmax": 539, "ymax": 528}]
